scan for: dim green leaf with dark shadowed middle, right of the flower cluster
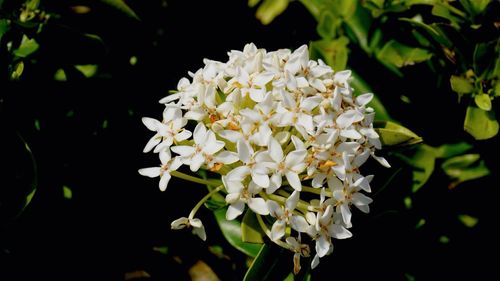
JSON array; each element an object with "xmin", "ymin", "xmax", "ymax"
[{"xmin": 441, "ymin": 154, "xmax": 490, "ymax": 189}]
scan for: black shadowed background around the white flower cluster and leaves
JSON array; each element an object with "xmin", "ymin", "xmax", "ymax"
[{"xmin": 0, "ymin": 1, "xmax": 499, "ymax": 280}]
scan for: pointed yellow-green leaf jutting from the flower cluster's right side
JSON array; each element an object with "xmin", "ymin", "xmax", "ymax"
[{"xmin": 374, "ymin": 121, "xmax": 422, "ymax": 146}]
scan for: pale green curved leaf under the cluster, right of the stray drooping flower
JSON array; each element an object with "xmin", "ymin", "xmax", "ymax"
[{"xmin": 214, "ymin": 208, "xmax": 262, "ymax": 257}]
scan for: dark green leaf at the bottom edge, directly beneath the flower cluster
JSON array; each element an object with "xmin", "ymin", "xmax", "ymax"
[{"xmin": 243, "ymin": 244, "xmax": 292, "ymax": 281}]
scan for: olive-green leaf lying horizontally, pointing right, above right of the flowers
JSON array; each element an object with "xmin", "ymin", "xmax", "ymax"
[{"xmin": 377, "ymin": 40, "xmax": 432, "ymax": 67}]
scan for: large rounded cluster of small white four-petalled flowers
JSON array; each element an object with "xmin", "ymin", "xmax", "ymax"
[{"xmin": 139, "ymin": 44, "xmax": 389, "ymax": 272}]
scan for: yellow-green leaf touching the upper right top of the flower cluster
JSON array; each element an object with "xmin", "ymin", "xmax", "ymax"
[{"xmin": 309, "ymin": 37, "xmax": 349, "ymax": 71}]
